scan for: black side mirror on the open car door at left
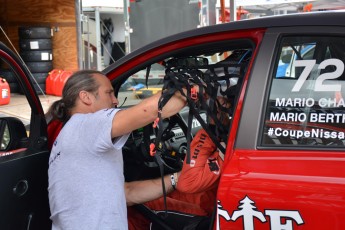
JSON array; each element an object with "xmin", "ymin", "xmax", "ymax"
[{"xmin": 0, "ymin": 117, "xmax": 28, "ymax": 151}]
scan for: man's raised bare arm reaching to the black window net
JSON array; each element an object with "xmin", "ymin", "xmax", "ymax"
[{"xmin": 111, "ymin": 91, "xmax": 186, "ymax": 138}]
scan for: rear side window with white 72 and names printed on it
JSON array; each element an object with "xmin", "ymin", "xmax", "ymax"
[{"xmin": 261, "ymin": 37, "xmax": 345, "ymax": 147}]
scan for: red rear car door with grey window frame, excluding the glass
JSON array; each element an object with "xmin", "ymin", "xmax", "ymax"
[{"xmin": 218, "ymin": 27, "xmax": 345, "ymax": 229}]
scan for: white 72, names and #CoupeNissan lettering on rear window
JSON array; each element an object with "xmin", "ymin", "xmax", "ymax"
[{"xmin": 267, "ymin": 58, "xmax": 345, "ymax": 140}]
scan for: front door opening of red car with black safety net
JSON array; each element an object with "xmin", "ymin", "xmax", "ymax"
[{"xmin": 115, "ymin": 39, "xmax": 254, "ymax": 181}]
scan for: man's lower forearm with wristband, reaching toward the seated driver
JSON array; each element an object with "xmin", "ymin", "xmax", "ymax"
[{"xmin": 125, "ymin": 175, "xmax": 174, "ymax": 206}]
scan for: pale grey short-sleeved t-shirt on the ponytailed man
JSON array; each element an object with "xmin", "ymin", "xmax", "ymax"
[{"xmin": 48, "ymin": 109, "xmax": 128, "ymax": 230}]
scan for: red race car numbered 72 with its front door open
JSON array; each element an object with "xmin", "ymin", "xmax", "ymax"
[{"xmin": 0, "ymin": 11, "xmax": 345, "ymax": 230}]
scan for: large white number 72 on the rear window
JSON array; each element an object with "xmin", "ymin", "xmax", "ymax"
[{"xmin": 291, "ymin": 58, "xmax": 344, "ymax": 92}]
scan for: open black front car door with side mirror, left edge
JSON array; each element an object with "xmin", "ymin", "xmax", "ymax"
[{"xmin": 0, "ymin": 42, "xmax": 51, "ymax": 230}]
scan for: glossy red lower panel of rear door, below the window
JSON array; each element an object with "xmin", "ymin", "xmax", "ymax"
[{"xmin": 218, "ymin": 150, "xmax": 345, "ymax": 229}]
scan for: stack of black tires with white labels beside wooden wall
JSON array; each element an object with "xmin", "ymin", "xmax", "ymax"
[{"xmin": 18, "ymin": 27, "xmax": 53, "ymax": 94}]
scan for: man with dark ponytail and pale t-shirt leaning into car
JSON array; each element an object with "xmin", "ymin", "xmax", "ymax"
[{"xmin": 48, "ymin": 70, "xmax": 186, "ymax": 230}]
